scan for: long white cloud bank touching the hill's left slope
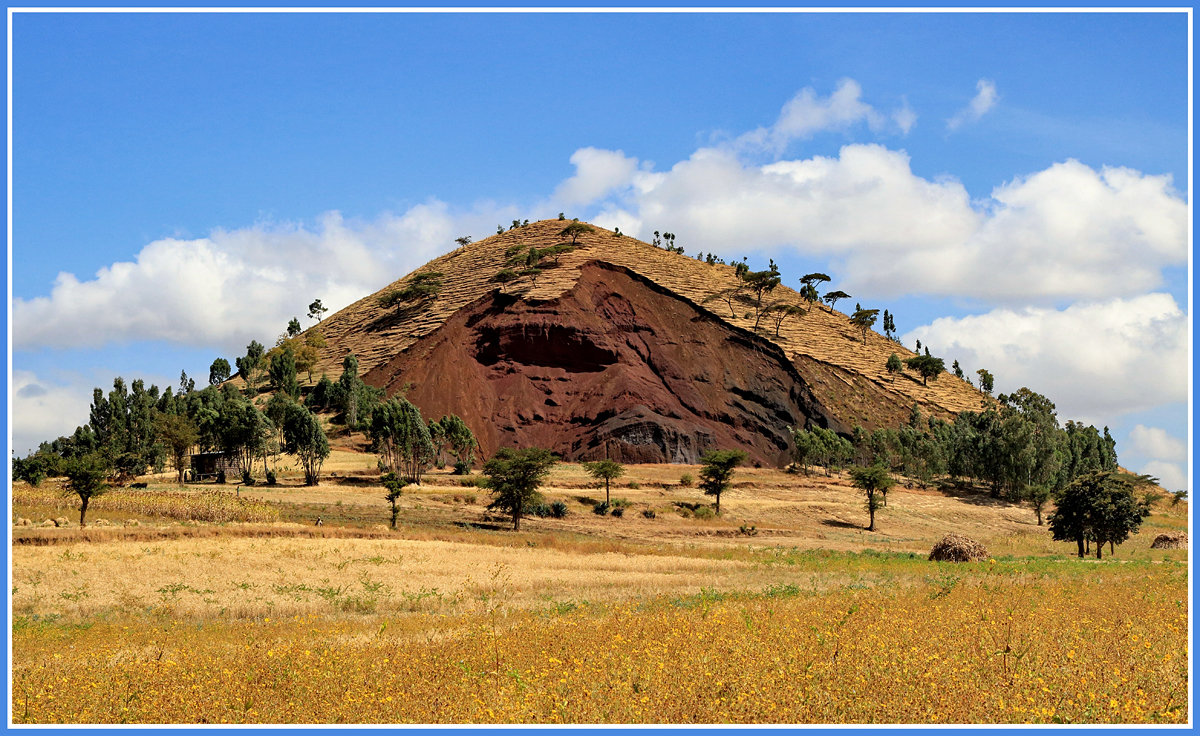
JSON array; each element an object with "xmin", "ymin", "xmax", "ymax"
[{"xmin": 12, "ymin": 202, "xmax": 509, "ymax": 349}]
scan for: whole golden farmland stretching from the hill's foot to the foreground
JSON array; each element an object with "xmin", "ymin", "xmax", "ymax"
[{"xmin": 11, "ymin": 448, "xmax": 1189, "ymax": 723}]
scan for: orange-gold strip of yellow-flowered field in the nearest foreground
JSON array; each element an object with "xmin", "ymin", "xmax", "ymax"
[{"xmin": 12, "ymin": 557, "xmax": 1188, "ymax": 723}]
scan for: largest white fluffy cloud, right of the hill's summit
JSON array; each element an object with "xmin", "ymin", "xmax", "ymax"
[{"xmin": 585, "ymin": 144, "xmax": 1187, "ymax": 304}]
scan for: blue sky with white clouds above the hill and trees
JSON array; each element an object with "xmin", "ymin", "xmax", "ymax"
[{"xmin": 12, "ymin": 13, "xmax": 1189, "ymax": 487}]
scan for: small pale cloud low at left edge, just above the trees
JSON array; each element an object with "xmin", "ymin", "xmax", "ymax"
[{"xmin": 10, "ymin": 370, "xmax": 91, "ymax": 456}]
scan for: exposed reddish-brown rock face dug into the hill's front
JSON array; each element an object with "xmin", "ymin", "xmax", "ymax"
[{"xmin": 364, "ymin": 262, "xmax": 848, "ymax": 465}]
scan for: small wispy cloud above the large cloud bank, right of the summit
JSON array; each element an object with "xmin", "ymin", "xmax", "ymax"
[{"xmin": 736, "ymin": 79, "xmax": 917, "ymax": 152}]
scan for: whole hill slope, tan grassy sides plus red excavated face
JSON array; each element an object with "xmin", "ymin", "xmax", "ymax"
[{"xmin": 304, "ymin": 220, "xmax": 980, "ymax": 462}]
